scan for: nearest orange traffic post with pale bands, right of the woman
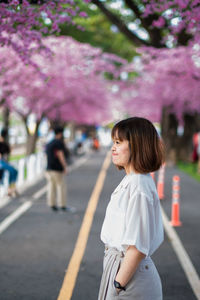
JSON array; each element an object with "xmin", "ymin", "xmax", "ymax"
[{"xmin": 170, "ymin": 176, "xmax": 182, "ymax": 227}]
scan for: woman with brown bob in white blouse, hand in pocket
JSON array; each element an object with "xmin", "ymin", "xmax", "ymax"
[{"xmin": 98, "ymin": 117, "xmax": 163, "ymax": 300}]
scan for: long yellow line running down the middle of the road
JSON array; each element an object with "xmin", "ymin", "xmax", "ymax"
[{"xmin": 57, "ymin": 151, "xmax": 111, "ymax": 300}]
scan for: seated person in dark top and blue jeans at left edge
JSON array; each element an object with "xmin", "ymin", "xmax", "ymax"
[{"xmin": 0, "ymin": 128, "xmax": 19, "ymax": 197}]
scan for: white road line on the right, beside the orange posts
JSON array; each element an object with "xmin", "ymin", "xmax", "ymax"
[{"xmin": 161, "ymin": 207, "xmax": 200, "ymax": 300}]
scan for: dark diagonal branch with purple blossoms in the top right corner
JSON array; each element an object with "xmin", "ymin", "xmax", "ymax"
[{"xmin": 91, "ymin": 0, "xmax": 200, "ymax": 49}]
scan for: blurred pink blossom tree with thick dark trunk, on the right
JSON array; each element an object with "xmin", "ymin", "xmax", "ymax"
[{"xmin": 126, "ymin": 45, "xmax": 200, "ymax": 160}]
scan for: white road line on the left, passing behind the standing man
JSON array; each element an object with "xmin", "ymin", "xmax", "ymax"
[{"xmin": 0, "ymin": 155, "xmax": 89, "ymax": 234}]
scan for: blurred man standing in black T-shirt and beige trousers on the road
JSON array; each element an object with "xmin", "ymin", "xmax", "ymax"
[{"xmin": 46, "ymin": 127, "xmax": 68, "ymax": 211}]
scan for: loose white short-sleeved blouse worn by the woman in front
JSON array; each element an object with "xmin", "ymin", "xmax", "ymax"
[{"xmin": 101, "ymin": 173, "xmax": 163, "ymax": 256}]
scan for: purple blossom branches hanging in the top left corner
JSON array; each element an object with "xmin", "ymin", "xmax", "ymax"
[{"xmin": 0, "ymin": 0, "xmax": 87, "ymax": 65}]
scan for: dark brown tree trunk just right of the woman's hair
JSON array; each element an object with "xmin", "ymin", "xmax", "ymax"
[{"xmin": 161, "ymin": 107, "xmax": 178, "ymax": 165}]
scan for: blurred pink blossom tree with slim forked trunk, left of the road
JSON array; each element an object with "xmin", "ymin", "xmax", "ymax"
[{"xmin": 0, "ymin": 37, "xmax": 126, "ymax": 152}]
